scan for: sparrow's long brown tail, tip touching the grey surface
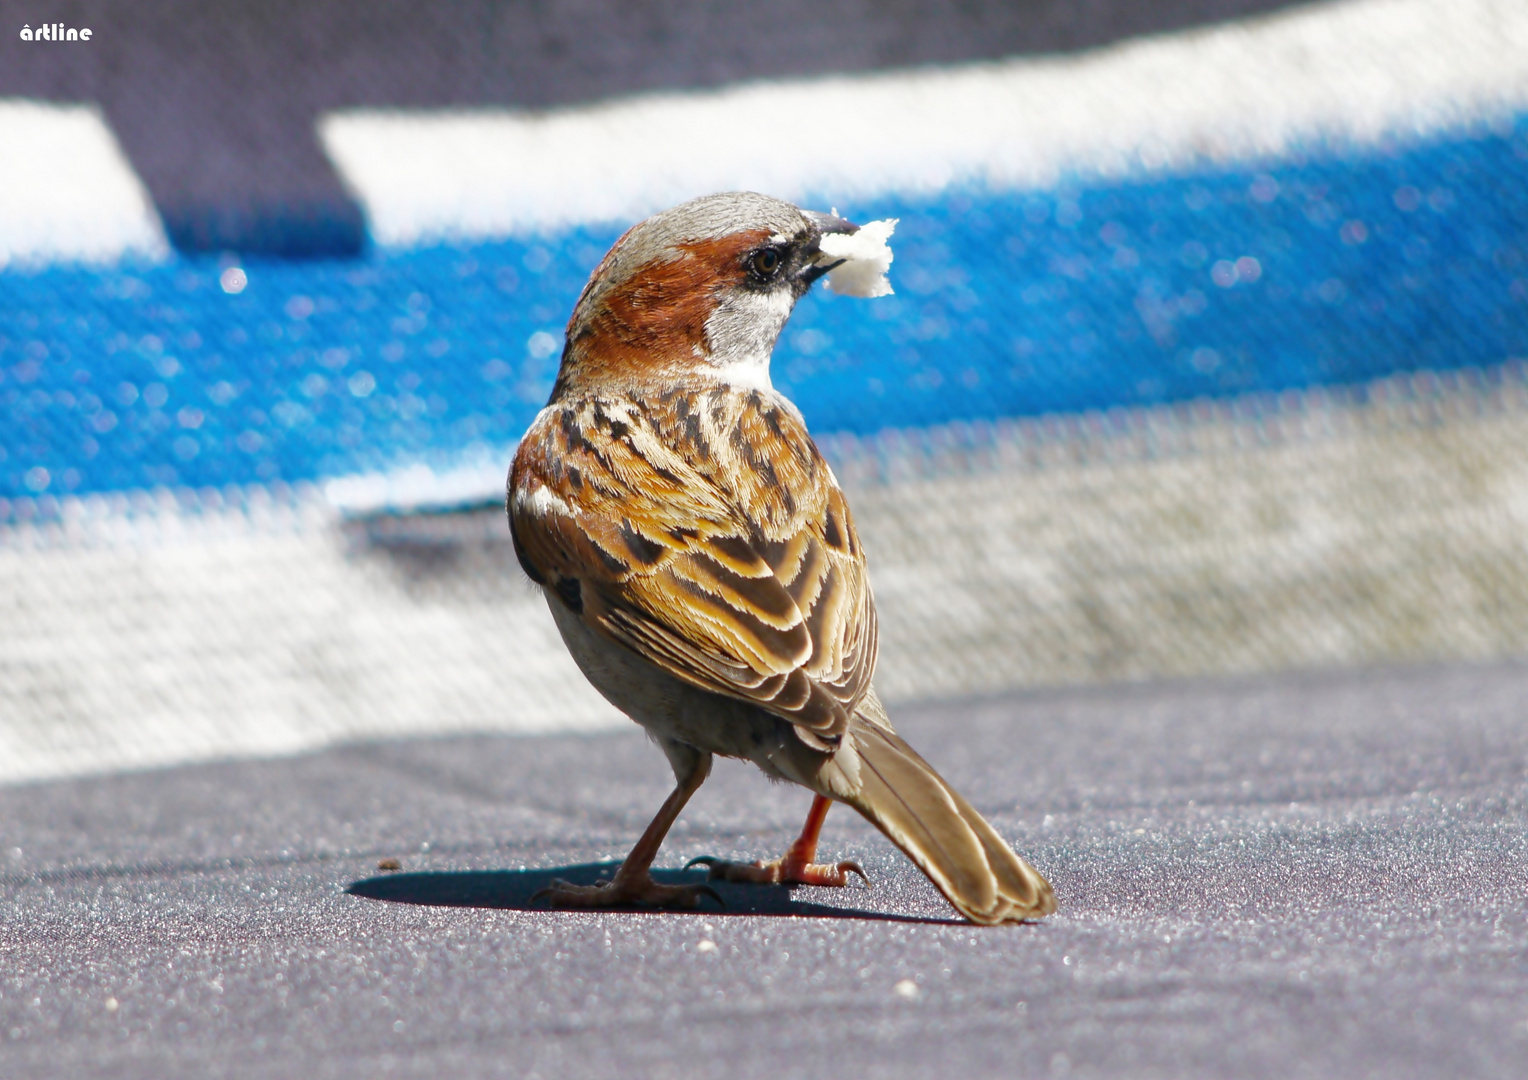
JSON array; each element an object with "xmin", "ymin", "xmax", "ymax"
[{"xmin": 847, "ymin": 715, "xmax": 1056, "ymax": 926}]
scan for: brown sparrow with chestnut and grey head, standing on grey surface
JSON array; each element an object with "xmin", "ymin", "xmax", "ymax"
[{"xmin": 506, "ymin": 191, "xmax": 1056, "ymax": 926}]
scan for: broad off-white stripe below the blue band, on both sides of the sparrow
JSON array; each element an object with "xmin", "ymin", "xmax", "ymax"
[{"xmin": 0, "ymin": 364, "xmax": 1528, "ymax": 782}]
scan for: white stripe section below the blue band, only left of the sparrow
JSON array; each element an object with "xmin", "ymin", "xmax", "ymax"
[{"xmin": 0, "ymin": 489, "xmax": 630, "ymax": 784}]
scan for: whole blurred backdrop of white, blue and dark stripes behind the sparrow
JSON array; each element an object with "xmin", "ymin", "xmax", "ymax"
[{"xmin": 0, "ymin": 0, "xmax": 1528, "ymax": 782}]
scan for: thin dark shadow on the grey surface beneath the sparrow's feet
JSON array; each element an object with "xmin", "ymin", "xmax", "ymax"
[{"xmin": 345, "ymin": 862, "xmax": 958, "ymax": 924}]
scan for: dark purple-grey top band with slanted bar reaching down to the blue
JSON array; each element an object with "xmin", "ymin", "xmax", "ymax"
[{"xmin": 0, "ymin": 0, "xmax": 1314, "ymax": 258}]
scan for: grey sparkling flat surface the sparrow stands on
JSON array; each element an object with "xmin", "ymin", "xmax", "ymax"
[{"xmin": 0, "ymin": 664, "xmax": 1528, "ymax": 1080}]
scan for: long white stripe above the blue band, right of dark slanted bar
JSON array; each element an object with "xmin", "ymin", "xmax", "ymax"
[{"xmin": 318, "ymin": 0, "xmax": 1528, "ymax": 246}]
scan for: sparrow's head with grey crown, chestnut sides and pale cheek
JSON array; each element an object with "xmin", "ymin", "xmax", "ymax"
[{"xmin": 552, "ymin": 191, "xmax": 859, "ymax": 400}]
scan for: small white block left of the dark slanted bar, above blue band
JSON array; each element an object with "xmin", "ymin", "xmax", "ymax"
[{"xmin": 0, "ymin": 99, "xmax": 170, "ymax": 269}]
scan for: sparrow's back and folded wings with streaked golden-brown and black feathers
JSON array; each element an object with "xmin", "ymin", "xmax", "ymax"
[{"xmin": 509, "ymin": 385, "xmax": 877, "ymax": 749}]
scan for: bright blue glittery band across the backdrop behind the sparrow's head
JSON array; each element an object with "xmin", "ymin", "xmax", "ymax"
[{"xmin": 0, "ymin": 118, "xmax": 1528, "ymax": 498}]
